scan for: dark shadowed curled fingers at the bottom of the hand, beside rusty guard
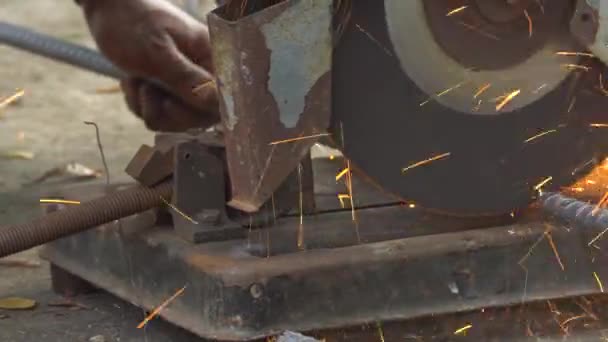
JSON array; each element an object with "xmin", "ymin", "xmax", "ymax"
[{"xmin": 138, "ymin": 83, "xmax": 219, "ymax": 132}]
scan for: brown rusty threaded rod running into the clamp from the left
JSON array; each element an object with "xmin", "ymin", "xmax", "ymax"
[{"xmin": 0, "ymin": 181, "xmax": 172, "ymax": 258}]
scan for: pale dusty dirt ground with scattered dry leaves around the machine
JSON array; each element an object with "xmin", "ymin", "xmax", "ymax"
[{"xmin": 0, "ymin": 0, "xmax": 608, "ymax": 342}]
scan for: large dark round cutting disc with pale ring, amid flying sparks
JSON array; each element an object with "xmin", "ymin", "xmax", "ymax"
[{"xmin": 331, "ymin": 0, "xmax": 600, "ymax": 215}]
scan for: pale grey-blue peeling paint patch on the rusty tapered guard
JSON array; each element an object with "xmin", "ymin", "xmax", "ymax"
[{"xmin": 261, "ymin": 0, "xmax": 332, "ymax": 128}]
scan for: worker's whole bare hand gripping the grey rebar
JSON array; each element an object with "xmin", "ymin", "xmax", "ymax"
[{"xmin": 76, "ymin": 0, "xmax": 219, "ymax": 131}]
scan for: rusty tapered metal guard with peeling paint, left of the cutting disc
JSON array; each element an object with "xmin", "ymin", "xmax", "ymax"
[{"xmin": 209, "ymin": 0, "xmax": 332, "ymax": 212}]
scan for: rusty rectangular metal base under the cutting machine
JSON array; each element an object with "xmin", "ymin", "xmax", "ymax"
[{"xmin": 39, "ymin": 186, "xmax": 608, "ymax": 340}]
